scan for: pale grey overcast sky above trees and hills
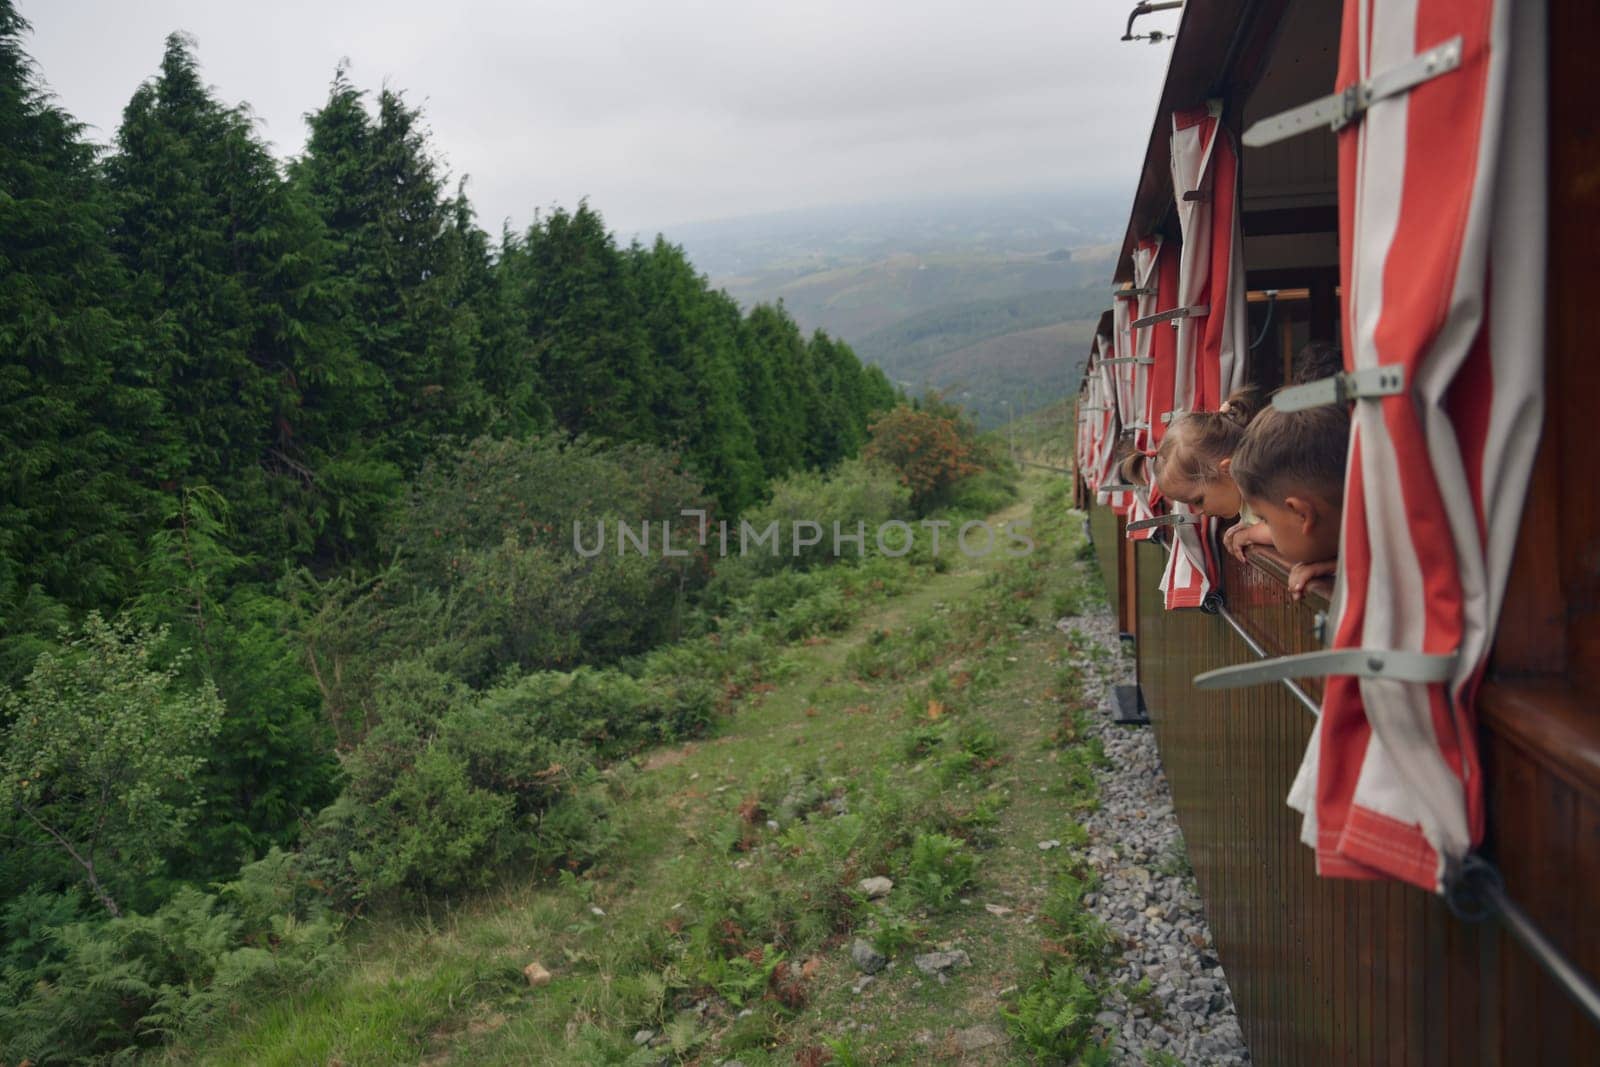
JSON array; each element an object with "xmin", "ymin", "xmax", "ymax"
[{"xmin": 18, "ymin": 0, "xmax": 1176, "ymax": 232}]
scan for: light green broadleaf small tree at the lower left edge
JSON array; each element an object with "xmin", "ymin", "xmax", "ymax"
[{"xmin": 0, "ymin": 613, "xmax": 222, "ymax": 915}]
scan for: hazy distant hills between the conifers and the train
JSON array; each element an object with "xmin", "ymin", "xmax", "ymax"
[{"xmin": 667, "ymin": 192, "xmax": 1125, "ymax": 427}]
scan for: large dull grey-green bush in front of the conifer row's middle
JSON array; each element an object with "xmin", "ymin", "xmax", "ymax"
[{"xmin": 285, "ymin": 438, "xmax": 710, "ymax": 726}]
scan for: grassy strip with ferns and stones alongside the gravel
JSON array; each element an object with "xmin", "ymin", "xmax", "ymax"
[{"xmin": 168, "ymin": 477, "xmax": 1115, "ymax": 1067}]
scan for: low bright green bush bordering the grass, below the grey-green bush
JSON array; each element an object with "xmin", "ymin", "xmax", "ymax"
[{"xmin": 300, "ymin": 661, "xmax": 681, "ymax": 901}]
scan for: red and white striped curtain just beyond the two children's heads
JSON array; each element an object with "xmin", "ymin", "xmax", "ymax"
[{"xmin": 1155, "ymin": 102, "xmax": 1250, "ymax": 609}]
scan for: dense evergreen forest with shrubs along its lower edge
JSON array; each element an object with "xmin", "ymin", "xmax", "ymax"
[{"xmin": 0, "ymin": 0, "xmax": 940, "ymax": 1062}]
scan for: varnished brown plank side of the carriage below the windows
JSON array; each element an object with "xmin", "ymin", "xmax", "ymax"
[{"xmin": 1093, "ymin": 537, "xmax": 1600, "ymax": 1067}]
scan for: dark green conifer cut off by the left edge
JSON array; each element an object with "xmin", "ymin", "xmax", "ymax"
[{"xmin": 0, "ymin": 0, "xmax": 160, "ymax": 678}]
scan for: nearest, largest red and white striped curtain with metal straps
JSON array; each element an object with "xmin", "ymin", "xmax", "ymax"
[{"xmin": 1291, "ymin": 0, "xmax": 1546, "ymax": 891}]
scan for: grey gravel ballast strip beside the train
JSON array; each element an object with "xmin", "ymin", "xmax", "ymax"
[{"xmin": 1058, "ymin": 613, "xmax": 1250, "ymax": 1064}]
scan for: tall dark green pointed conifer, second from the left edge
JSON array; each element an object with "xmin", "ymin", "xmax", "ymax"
[{"xmin": 107, "ymin": 34, "xmax": 358, "ymax": 557}]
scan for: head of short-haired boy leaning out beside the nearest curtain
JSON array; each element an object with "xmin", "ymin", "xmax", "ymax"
[{"xmin": 1229, "ymin": 405, "xmax": 1350, "ymax": 563}]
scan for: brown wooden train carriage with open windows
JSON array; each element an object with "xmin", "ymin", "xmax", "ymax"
[{"xmin": 1077, "ymin": 0, "xmax": 1600, "ymax": 1067}]
